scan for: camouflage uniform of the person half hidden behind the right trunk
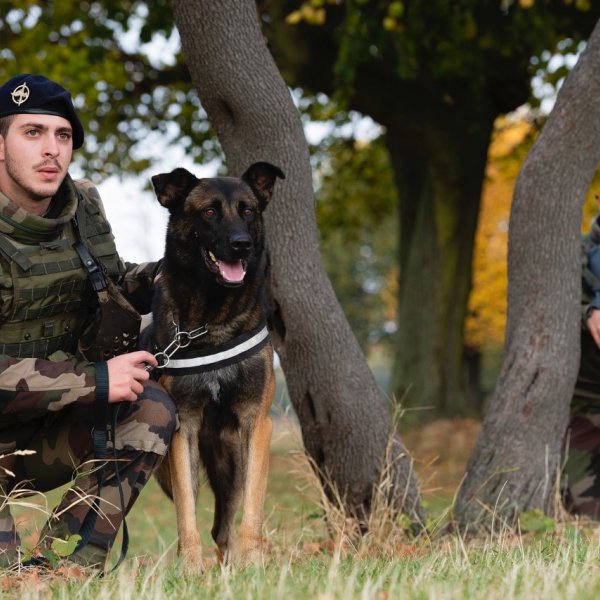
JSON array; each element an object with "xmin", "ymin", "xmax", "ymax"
[{"xmin": 564, "ymin": 217, "xmax": 600, "ymax": 520}]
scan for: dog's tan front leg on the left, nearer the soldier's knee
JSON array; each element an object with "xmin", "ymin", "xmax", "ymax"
[{"xmin": 169, "ymin": 430, "xmax": 203, "ymax": 573}]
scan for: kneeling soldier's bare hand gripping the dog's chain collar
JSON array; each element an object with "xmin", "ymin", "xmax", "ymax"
[{"xmin": 106, "ymin": 350, "xmax": 156, "ymax": 403}]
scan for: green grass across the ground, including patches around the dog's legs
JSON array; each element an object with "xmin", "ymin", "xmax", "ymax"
[{"xmin": 0, "ymin": 422, "xmax": 600, "ymax": 600}]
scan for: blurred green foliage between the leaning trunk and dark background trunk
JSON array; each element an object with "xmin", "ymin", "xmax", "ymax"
[{"xmin": 316, "ymin": 132, "xmax": 398, "ymax": 351}]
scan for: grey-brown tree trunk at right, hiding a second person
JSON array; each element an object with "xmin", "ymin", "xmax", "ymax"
[{"xmin": 456, "ymin": 19, "xmax": 600, "ymax": 528}]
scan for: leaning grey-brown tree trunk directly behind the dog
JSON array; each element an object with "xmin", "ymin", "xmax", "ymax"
[{"xmin": 173, "ymin": 0, "xmax": 420, "ymax": 518}]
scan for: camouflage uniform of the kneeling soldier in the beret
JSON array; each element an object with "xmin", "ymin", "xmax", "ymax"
[{"xmin": 0, "ymin": 176, "xmax": 177, "ymax": 565}]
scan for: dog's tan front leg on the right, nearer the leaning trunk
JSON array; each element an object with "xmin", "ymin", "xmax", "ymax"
[{"xmin": 234, "ymin": 376, "xmax": 275, "ymax": 563}]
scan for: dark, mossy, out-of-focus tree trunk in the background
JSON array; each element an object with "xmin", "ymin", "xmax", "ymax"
[{"xmin": 387, "ymin": 110, "xmax": 495, "ymax": 425}]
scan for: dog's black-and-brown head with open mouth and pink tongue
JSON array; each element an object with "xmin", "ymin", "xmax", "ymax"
[{"xmin": 152, "ymin": 162, "xmax": 285, "ymax": 287}]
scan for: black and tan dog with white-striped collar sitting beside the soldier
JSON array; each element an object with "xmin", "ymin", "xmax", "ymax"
[{"xmin": 151, "ymin": 162, "xmax": 285, "ymax": 571}]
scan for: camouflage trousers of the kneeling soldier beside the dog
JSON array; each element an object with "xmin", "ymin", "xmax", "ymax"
[{"xmin": 0, "ymin": 381, "xmax": 177, "ymax": 566}]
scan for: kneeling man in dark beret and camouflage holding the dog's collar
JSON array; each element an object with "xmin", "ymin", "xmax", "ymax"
[{"xmin": 0, "ymin": 74, "xmax": 177, "ymax": 568}]
